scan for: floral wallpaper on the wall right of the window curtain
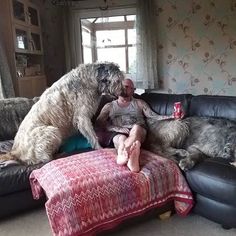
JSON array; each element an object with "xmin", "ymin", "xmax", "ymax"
[{"xmin": 155, "ymin": 0, "xmax": 236, "ymax": 96}]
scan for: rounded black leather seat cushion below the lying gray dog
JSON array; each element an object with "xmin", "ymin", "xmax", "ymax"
[{"xmin": 186, "ymin": 158, "xmax": 236, "ymax": 207}]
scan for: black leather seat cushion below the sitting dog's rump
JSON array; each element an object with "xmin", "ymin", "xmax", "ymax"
[{"xmin": 0, "ymin": 163, "xmax": 45, "ymax": 196}]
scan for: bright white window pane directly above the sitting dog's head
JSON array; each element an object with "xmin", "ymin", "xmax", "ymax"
[{"xmin": 98, "ymin": 48, "xmax": 126, "ymax": 71}]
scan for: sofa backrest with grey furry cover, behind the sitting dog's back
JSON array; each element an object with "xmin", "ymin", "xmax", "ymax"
[{"xmin": 0, "ymin": 97, "xmax": 39, "ymax": 140}]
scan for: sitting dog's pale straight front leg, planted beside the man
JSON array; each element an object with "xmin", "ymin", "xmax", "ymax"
[{"xmin": 77, "ymin": 117, "xmax": 101, "ymax": 149}]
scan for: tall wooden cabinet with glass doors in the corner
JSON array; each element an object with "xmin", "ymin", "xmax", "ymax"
[{"xmin": 0, "ymin": 0, "xmax": 47, "ymax": 98}]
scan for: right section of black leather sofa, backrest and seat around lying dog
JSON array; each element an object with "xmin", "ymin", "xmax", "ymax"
[{"xmin": 142, "ymin": 93, "xmax": 236, "ymax": 228}]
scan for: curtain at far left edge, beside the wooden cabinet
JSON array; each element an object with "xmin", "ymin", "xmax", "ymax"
[{"xmin": 0, "ymin": 39, "xmax": 15, "ymax": 99}]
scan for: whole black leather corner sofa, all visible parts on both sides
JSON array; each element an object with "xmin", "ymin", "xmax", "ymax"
[{"xmin": 0, "ymin": 93, "xmax": 236, "ymax": 228}]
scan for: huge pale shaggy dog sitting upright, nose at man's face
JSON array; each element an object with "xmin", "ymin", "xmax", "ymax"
[{"xmin": 0, "ymin": 63, "xmax": 123, "ymax": 164}]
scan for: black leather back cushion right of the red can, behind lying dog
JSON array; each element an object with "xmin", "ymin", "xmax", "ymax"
[{"xmin": 189, "ymin": 95, "xmax": 236, "ymax": 120}]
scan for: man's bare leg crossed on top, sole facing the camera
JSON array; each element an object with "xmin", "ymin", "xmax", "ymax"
[{"xmin": 124, "ymin": 125, "xmax": 147, "ymax": 172}]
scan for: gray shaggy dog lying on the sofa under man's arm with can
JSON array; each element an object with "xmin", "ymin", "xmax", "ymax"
[{"xmin": 145, "ymin": 117, "xmax": 236, "ymax": 171}]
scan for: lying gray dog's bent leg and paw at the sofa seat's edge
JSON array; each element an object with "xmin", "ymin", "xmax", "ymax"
[{"xmin": 179, "ymin": 145, "xmax": 207, "ymax": 171}]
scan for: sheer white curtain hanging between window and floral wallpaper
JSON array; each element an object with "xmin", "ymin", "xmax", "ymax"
[{"xmin": 135, "ymin": 0, "xmax": 158, "ymax": 89}]
